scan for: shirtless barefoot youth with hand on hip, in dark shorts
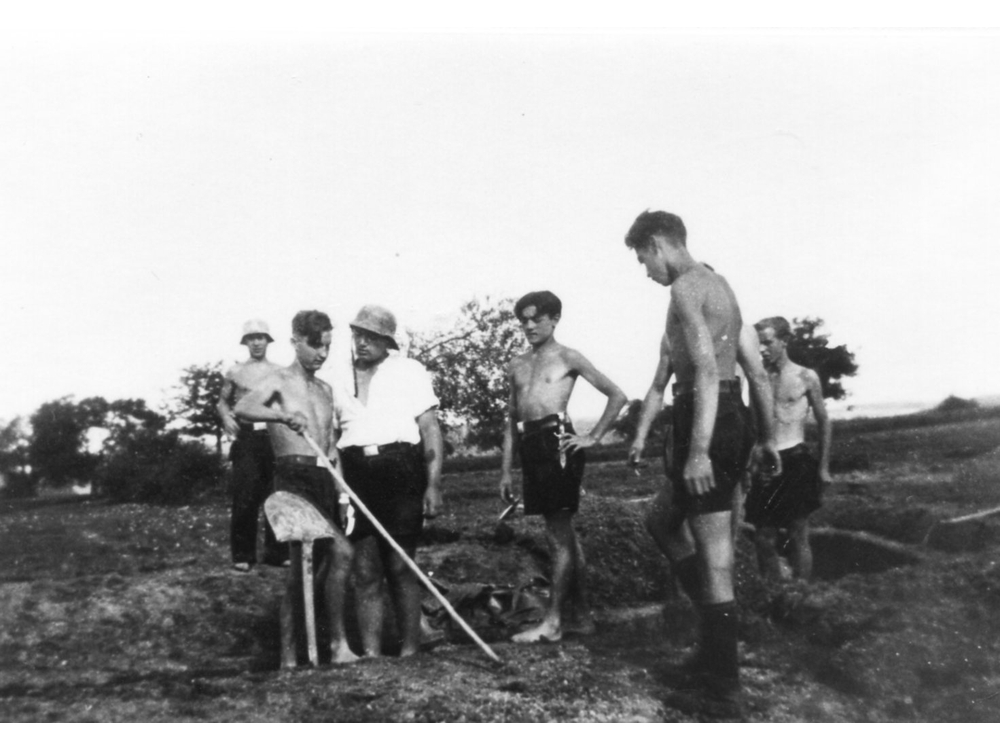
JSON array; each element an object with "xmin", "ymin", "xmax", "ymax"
[{"xmin": 500, "ymin": 292, "xmax": 627, "ymax": 643}]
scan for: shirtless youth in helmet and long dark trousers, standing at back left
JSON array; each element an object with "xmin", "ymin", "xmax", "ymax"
[{"xmin": 216, "ymin": 320, "xmax": 288, "ymax": 573}]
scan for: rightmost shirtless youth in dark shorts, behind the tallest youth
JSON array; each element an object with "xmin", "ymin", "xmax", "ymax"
[{"xmin": 746, "ymin": 317, "xmax": 833, "ymax": 579}]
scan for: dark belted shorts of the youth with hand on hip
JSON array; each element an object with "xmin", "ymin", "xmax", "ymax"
[{"xmin": 520, "ymin": 415, "xmax": 587, "ymax": 516}]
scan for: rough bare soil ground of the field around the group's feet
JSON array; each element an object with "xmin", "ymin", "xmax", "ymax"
[{"xmin": 0, "ymin": 417, "xmax": 1000, "ymax": 722}]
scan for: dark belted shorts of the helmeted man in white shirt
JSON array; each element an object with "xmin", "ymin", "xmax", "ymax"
[{"xmin": 340, "ymin": 443, "xmax": 427, "ymax": 541}]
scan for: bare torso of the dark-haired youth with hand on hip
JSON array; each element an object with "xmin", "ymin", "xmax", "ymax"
[{"xmin": 510, "ymin": 342, "xmax": 579, "ymax": 421}]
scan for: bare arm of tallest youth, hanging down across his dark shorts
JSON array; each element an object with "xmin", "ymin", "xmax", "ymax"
[{"xmin": 671, "ymin": 283, "xmax": 719, "ymax": 495}]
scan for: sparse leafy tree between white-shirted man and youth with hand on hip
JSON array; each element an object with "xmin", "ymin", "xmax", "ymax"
[{"xmin": 410, "ymin": 297, "xmax": 524, "ymax": 447}]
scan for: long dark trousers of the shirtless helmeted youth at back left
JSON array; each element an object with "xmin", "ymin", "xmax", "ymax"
[{"xmin": 229, "ymin": 426, "xmax": 288, "ymax": 564}]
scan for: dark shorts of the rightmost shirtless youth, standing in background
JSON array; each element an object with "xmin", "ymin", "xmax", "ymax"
[{"xmin": 746, "ymin": 443, "xmax": 822, "ymax": 529}]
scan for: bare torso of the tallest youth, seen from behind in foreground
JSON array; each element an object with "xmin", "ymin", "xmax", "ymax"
[{"xmin": 665, "ymin": 265, "xmax": 743, "ymax": 383}]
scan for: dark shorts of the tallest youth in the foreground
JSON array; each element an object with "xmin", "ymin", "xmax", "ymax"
[{"xmin": 670, "ymin": 389, "xmax": 753, "ymax": 516}]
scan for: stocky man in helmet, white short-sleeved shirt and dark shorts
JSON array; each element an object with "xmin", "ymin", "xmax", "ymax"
[{"xmin": 335, "ymin": 305, "xmax": 444, "ymax": 657}]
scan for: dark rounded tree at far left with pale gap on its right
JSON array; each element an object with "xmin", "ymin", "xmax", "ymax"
[{"xmin": 28, "ymin": 396, "xmax": 107, "ymax": 487}]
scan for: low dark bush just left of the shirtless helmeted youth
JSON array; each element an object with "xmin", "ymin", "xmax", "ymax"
[{"xmin": 95, "ymin": 429, "xmax": 224, "ymax": 505}]
